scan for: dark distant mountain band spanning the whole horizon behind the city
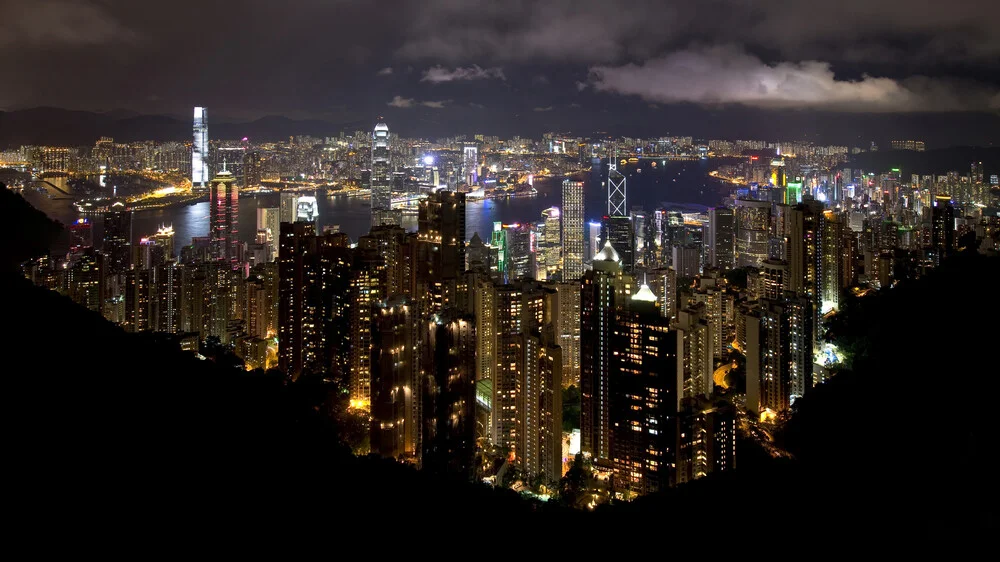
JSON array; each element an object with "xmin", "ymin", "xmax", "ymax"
[{"xmin": 0, "ymin": 104, "xmax": 1000, "ymax": 153}]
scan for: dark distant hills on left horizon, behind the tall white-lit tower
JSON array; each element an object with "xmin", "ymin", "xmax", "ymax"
[{"xmin": 0, "ymin": 107, "xmax": 353, "ymax": 148}]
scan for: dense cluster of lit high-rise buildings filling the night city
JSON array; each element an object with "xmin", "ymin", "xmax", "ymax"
[{"xmin": 15, "ymin": 108, "xmax": 1000, "ymax": 498}]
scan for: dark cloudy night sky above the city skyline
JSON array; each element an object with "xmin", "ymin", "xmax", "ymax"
[{"xmin": 0, "ymin": 0, "xmax": 1000, "ymax": 140}]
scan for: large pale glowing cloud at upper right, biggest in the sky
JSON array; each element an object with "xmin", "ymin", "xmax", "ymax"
[{"xmin": 590, "ymin": 46, "xmax": 1000, "ymax": 112}]
